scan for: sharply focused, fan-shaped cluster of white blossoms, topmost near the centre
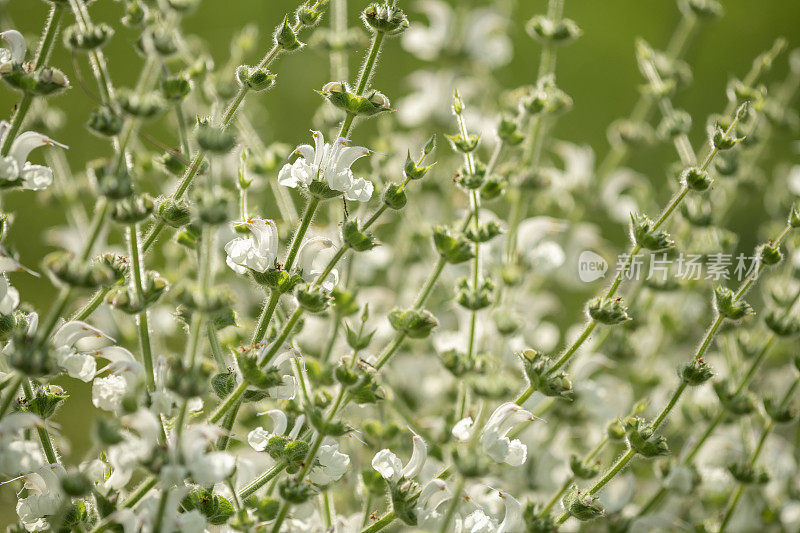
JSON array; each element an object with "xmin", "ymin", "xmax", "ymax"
[{"xmin": 278, "ymin": 130, "xmax": 374, "ymax": 202}]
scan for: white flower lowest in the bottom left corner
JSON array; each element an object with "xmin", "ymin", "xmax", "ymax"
[{"xmin": 17, "ymin": 463, "xmax": 66, "ymax": 531}]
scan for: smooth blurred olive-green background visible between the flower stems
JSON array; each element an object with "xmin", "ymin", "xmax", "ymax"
[{"xmin": 0, "ymin": 0, "xmax": 800, "ymax": 524}]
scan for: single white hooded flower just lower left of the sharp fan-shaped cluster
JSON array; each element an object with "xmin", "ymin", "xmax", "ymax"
[{"xmin": 225, "ymin": 218, "xmax": 278, "ymax": 274}]
